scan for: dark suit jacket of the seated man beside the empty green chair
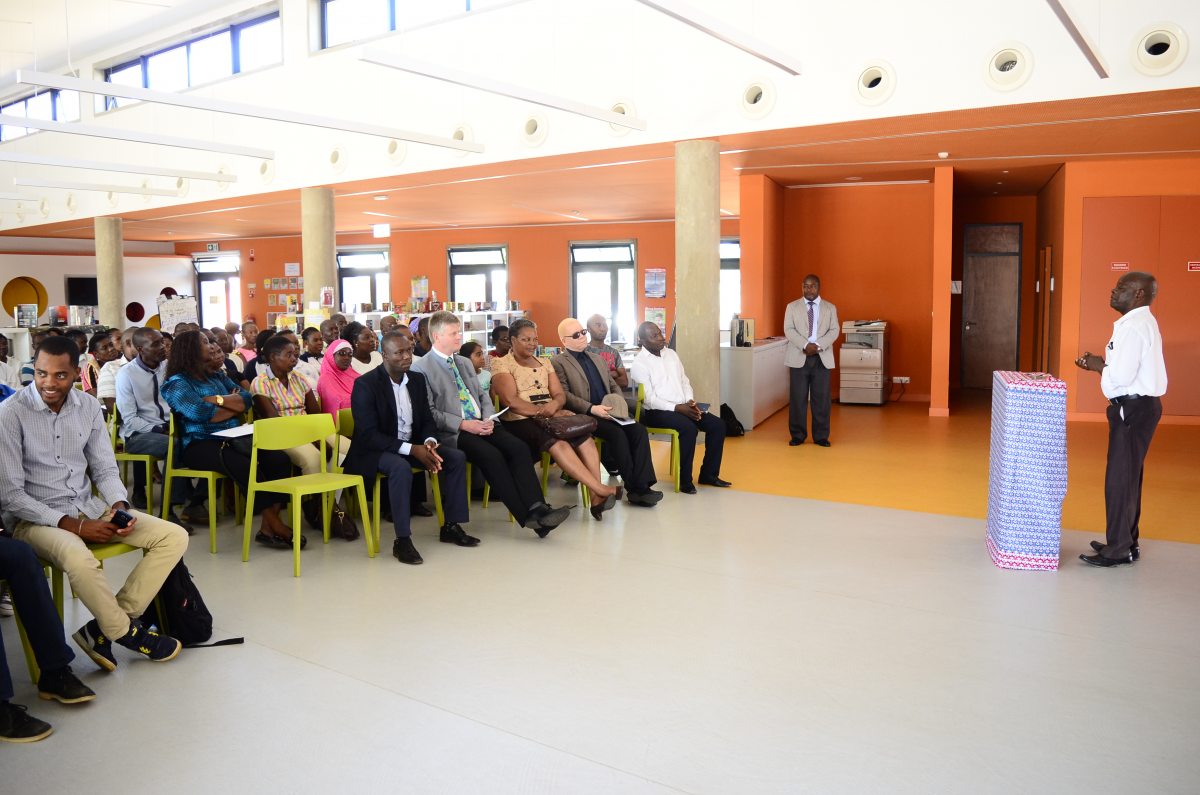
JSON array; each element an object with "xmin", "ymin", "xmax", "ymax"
[{"xmin": 344, "ymin": 366, "xmax": 437, "ymax": 479}]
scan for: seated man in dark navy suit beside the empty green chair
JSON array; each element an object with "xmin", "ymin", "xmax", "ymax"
[{"xmin": 344, "ymin": 331, "xmax": 479, "ymax": 564}]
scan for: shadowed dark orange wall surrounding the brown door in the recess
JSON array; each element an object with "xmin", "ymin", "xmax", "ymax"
[{"xmin": 950, "ymin": 196, "xmax": 1038, "ymax": 387}]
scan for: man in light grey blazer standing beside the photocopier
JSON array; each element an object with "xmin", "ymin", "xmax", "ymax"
[{"xmin": 784, "ymin": 274, "xmax": 841, "ymax": 447}]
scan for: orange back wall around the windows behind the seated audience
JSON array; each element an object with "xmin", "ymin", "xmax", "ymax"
[{"xmin": 175, "ymin": 220, "xmax": 738, "ymax": 343}]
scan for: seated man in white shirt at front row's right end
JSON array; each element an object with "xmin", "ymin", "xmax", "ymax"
[{"xmin": 630, "ymin": 322, "xmax": 731, "ymax": 494}]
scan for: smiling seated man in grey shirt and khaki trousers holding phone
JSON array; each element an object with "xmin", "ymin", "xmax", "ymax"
[{"xmin": 0, "ymin": 337, "xmax": 187, "ymax": 671}]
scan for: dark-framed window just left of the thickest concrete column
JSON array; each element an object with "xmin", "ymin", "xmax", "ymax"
[{"xmin": 571, "ymin": 241, "xmax": 637, "ymax": 342}]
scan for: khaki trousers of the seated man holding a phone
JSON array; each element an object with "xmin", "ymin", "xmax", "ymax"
[{"xmin": 13, "ymin": 509, "xmax": 187, "ymax": 640}]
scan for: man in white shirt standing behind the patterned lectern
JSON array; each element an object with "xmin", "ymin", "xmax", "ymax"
[{"xmin": 1075, "ymin": 271, "xmax": 1166, "ymax": 567}]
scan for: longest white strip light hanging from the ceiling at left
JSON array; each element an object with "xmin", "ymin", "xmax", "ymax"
[{"xmin": 16, "ymin": 70, "xmax": 484, "ymax": 153}]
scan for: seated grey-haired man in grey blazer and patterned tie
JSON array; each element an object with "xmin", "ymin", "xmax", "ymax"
[{"xmin": 412, "ymin": 312, "xmax": 570, "ymax": 538}]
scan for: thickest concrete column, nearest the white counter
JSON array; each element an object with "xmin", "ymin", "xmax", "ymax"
[{"xmin": 667, "ymin": 141, "xmax": 721, "ymax": 412}]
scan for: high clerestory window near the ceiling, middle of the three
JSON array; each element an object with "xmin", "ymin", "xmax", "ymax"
[{"xmin": 100, "ymin": 11, "xmax": 283, "ymax": 109}]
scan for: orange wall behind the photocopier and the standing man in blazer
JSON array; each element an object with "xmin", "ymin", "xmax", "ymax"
[{"xmin": 779, "ymin": 185, "xmax": 934, "ymax": 400}]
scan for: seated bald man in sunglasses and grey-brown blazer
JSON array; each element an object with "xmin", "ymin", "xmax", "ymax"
[{"xmin": 550, "ymin": 317, "xmax": 662, "ymax": 508}]
